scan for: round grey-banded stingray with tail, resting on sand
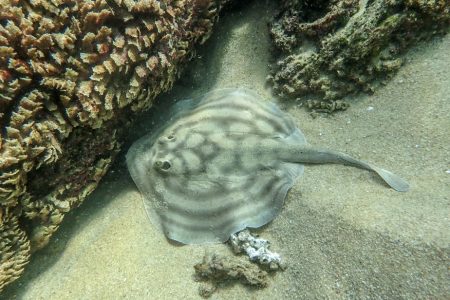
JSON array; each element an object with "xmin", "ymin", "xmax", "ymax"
[{"xmin": 127, "ymin": 89, "xmax": 409, "ymax": 244}]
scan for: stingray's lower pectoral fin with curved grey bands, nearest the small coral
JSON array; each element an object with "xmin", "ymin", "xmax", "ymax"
[{"xmin": 127, "ymin": 139, "xmax": 303, "ymax": 244}]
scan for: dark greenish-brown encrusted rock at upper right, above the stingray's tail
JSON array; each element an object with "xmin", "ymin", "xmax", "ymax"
[{"xmin": 269, "ymin": 0, "xmax": 450, "ymax": 111}]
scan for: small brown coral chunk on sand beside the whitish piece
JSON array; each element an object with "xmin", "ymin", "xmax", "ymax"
[{"xmin": 194, "ymin": 255, "xmax": 268, "ymax": 298}]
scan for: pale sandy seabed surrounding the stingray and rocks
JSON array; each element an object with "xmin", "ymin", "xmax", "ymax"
[{"xmin": 3, "ymin": 1, "xmax": 450, "ymax": 299}]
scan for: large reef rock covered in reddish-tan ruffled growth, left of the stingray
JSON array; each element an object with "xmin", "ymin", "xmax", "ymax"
[{"xmin": 0, "ymin": 0, "xmax": 225, "ymax": 290}]
